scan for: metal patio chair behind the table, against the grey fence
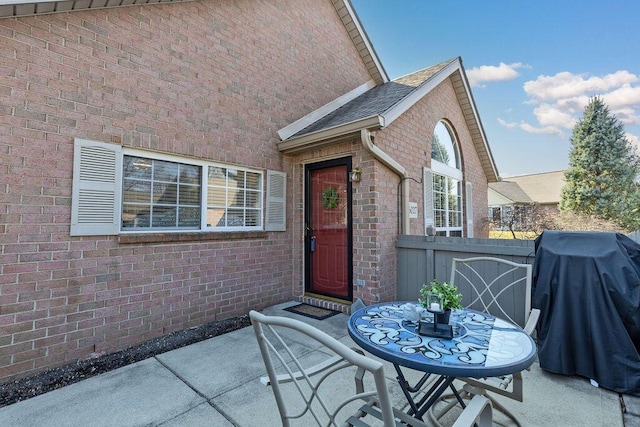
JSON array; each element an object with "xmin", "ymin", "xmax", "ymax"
[{"xmin": 429, "ymin": 257, "xmax": 540, "ymax": 425}]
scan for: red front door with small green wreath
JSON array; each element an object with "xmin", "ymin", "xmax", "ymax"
[{"xmin": 305, "ymin": 158, "xmax": 352, "ymax": 301}]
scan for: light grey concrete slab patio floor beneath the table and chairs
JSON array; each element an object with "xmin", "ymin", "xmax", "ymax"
[{"xmin": 0, "ymin": 302, "xmax": 640, "ymax": 427}]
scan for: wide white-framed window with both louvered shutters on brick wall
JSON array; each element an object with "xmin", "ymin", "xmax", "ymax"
[{"xmin": 71, "ymin": 139, "xmax": 286, "ymax": 235}]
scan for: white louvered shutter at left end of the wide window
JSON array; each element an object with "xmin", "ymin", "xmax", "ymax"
[{"xmin": 71, "ymin": 138, "xmax": 122, "ymax": 236}]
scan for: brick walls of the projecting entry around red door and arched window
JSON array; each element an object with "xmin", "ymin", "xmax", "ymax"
[{"xmin": 291, "ymin": 79, "xmax": 487, "ymax": 304}]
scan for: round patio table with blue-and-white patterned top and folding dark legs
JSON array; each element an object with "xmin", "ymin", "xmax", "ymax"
[{"xmin": 347, "ymin": 301, "xmax": 536, "ymax": 419}]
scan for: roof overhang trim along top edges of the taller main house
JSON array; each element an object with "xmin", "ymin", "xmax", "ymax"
[{"xmin": 0, "ymin": 0, "xmax": 389, "ymax": 84}]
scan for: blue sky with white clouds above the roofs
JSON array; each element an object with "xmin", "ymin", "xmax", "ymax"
[{"xmin": 351, "ymin": 0, "xmax": 640, "ymax": 178}]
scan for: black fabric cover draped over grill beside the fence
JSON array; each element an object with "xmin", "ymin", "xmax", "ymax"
[{"xmin": 532, "ymin": 231, "xmax": 640, "ymax": 395}]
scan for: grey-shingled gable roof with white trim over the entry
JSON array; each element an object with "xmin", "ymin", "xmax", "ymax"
[{"xmin": 278, "ymin": 57, "xmax": 498, "ymax": 182}]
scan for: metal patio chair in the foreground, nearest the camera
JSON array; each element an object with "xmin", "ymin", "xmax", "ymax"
[{"xmin": 249, "ymin": 311, "xmax": 492, "ymax": 427}]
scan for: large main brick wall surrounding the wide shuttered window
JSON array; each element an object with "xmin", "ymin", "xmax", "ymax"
[{"xmin": 0, "ymin": 0, "xmax": 370, "ymax": 381}]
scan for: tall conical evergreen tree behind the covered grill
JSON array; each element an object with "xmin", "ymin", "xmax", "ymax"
[{"xmin": 560, "ymin": 96, "xmax": 640, "ymax": 230}]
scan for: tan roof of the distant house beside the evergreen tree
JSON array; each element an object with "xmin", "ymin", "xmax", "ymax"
[{"xmin": 489, "ymin": 171, "xmax": 565, "ymax": 204}]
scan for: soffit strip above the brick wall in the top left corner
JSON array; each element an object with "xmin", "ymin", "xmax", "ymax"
[{"xmin": 0, "ymin": 0, "xmax": 195, "ymax": 18}]
